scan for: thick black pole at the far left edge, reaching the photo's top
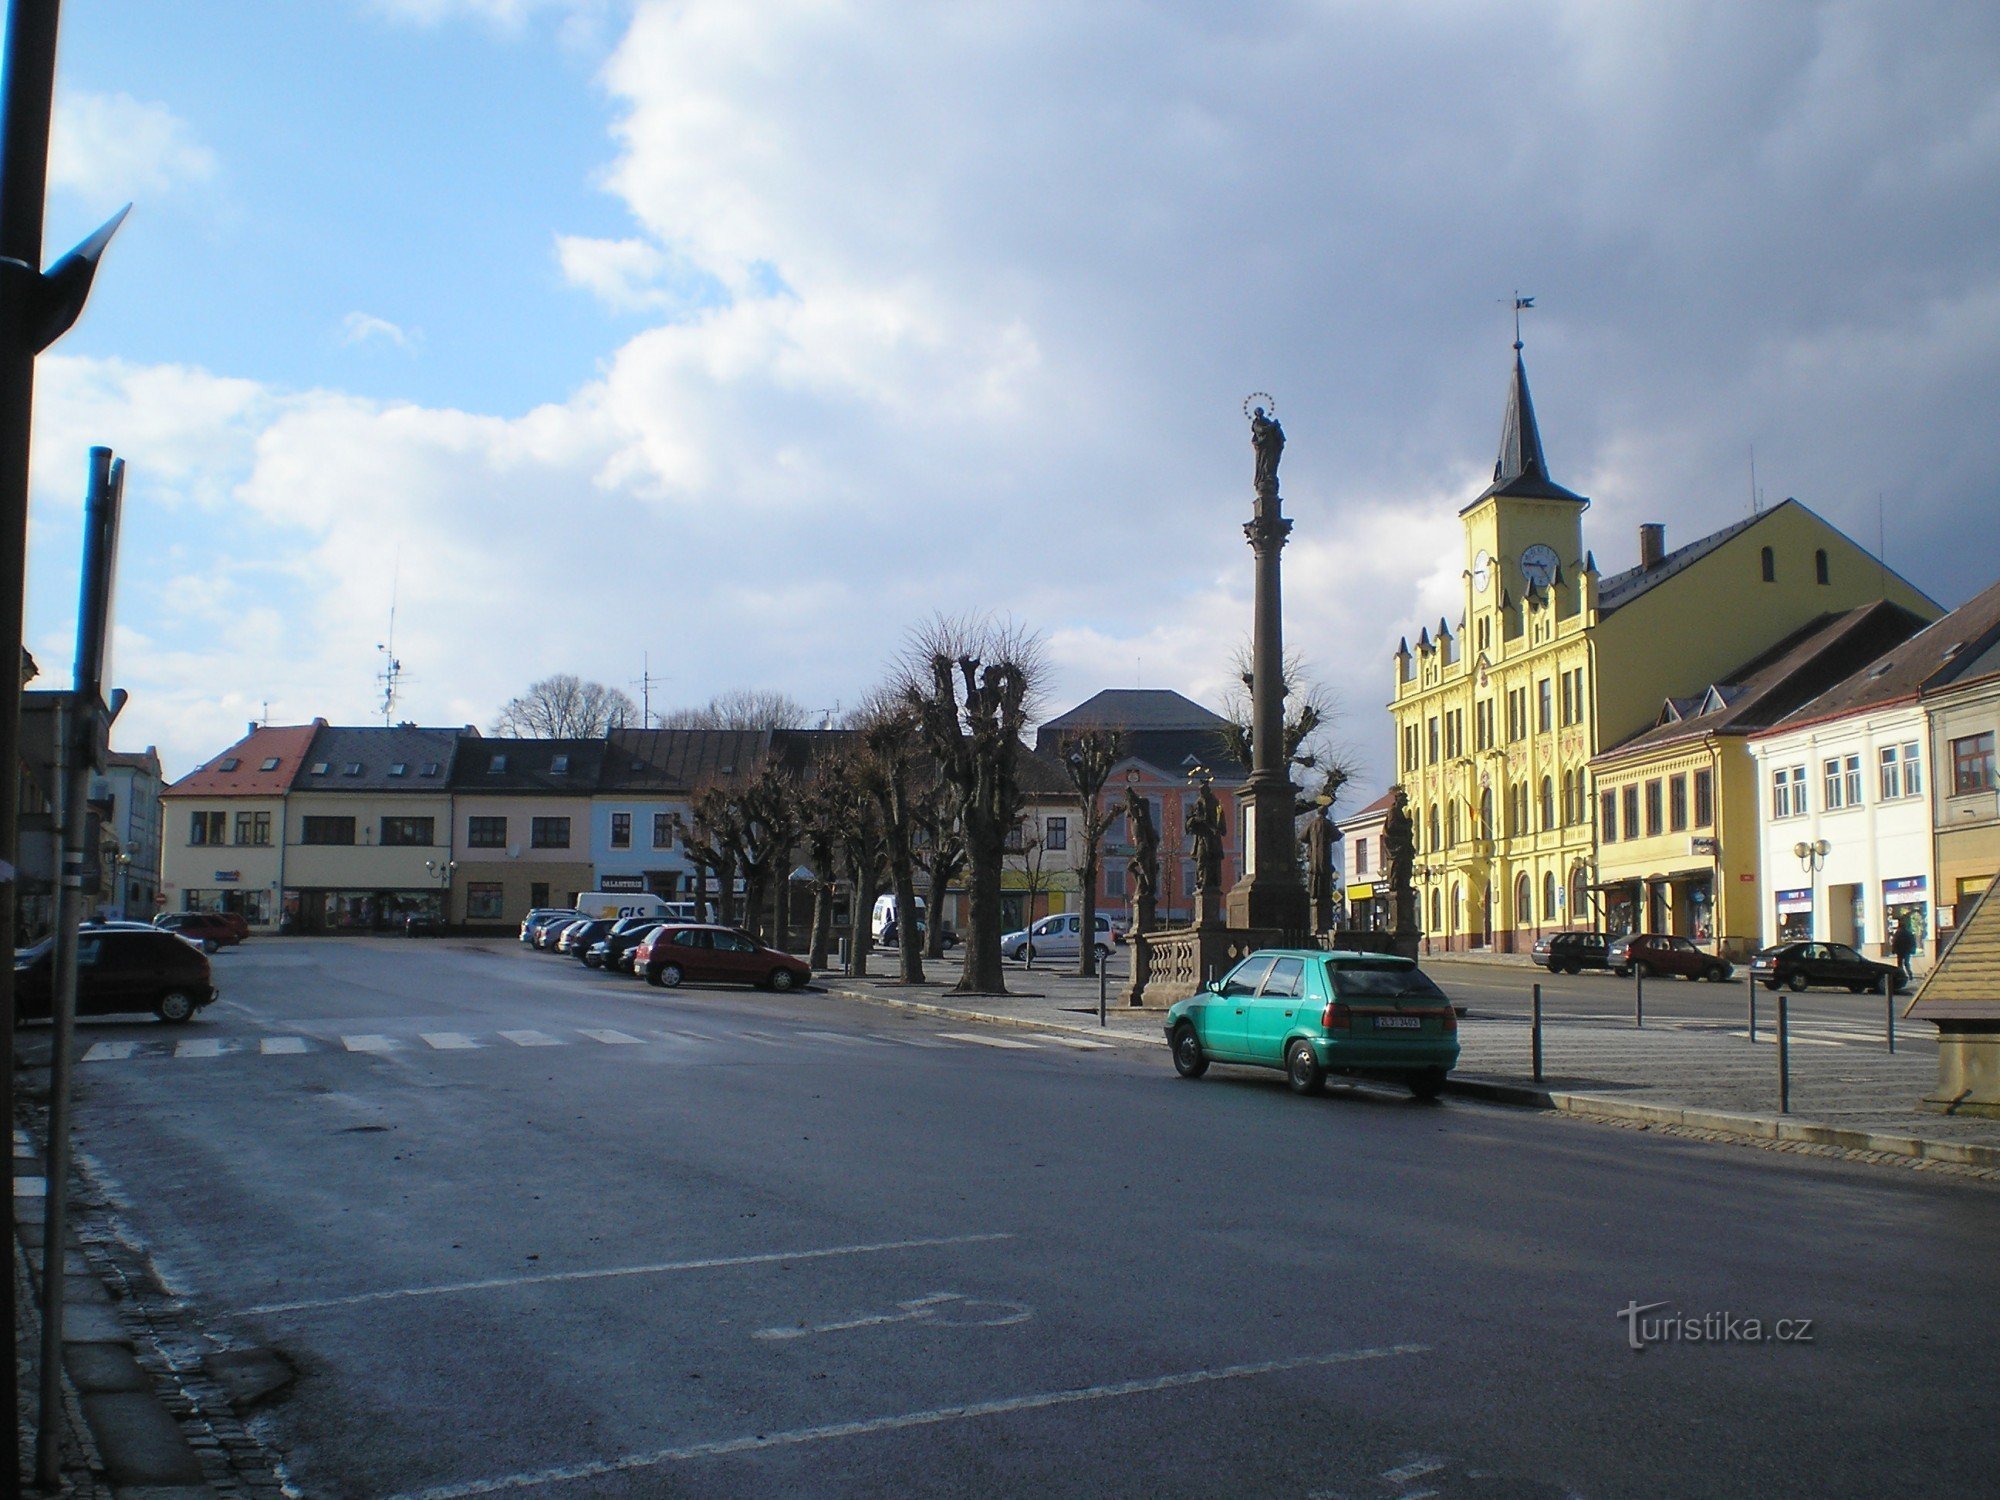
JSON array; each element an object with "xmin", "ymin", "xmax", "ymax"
[{"xmin": 0, "ymin": 0, "xmax": 60, "ymax": 1480}]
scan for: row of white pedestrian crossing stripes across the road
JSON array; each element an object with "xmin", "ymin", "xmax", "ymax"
[{"xmin": 78, "ymin": 1026, "xmax": 1112, "ymax": 1064}]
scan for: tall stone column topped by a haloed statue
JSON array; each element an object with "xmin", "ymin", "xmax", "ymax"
[{"xmin": 1228, "ymin": 396, "xmax": 1310, "ymax": 934}]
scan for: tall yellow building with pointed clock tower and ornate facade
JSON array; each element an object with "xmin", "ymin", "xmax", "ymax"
[{"xmin": 1390, "ymin": 344, "xmax": 1940, "ymax": 950}]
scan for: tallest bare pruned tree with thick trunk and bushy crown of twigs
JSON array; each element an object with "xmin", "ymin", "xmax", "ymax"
[{"xmin": 896, "ymin": 616, "xmax": 1046, "ymax": 994}]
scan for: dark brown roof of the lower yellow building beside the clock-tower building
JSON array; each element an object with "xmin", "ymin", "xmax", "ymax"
[{"xmin": 1590, "ymin": 600, "xmax": 1924, "ymax": 764}]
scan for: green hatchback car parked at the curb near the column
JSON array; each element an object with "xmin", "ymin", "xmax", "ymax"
[{"xmin": 1166, "ymin": 948, "xmax": 1458, "ymax": 1098}]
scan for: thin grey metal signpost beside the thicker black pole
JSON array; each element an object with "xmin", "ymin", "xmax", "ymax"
[{"xmin": 34, "ymin": 448, "xmax": 124, "ymax": 1490}]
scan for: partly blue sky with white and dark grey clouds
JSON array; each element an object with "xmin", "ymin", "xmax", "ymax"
[{"xmin": 28, "ymin": 0, "xmax": 2000, "ymax": 800}]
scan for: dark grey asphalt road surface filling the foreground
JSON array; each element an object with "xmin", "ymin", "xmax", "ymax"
[{"xmin": 47, "ymin": 940, "xmax": 2000, "ymax": 1500}]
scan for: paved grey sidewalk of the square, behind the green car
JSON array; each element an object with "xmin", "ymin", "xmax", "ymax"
[{"xmin": 816, "ymin": 952, "xmax": 2000, "ymax": 1180}]
